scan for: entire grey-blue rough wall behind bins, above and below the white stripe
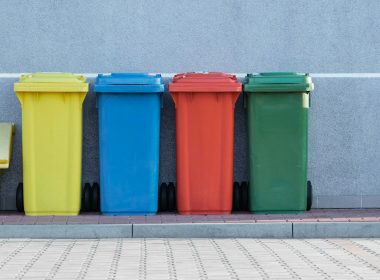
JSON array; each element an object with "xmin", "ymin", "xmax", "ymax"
[{"xmin": 0, "ymin": 0, "xmax": 380, "ymax": 209}]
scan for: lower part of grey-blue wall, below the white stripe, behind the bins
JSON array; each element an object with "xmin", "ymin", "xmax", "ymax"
[{"xmin": 0, "ymin": 77, "xmax": 380, "ymax": 209}]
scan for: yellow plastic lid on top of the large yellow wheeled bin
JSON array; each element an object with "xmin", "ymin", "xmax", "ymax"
[{"xmin": 14, "ymin": 73, "xmax": 88, "ymax": 92}]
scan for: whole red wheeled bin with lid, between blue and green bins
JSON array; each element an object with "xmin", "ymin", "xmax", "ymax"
[{"xmin": 169, "ymin": 73, "xmax": 242, "ymax": 214}]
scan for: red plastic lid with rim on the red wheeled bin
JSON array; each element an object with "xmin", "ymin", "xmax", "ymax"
[{"xmin": 169, "ymin": 72, "xmax": 242, "ymax": 92}]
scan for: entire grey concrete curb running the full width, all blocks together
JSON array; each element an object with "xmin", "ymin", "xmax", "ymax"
[{"xmin": 0, "ymin": 222, "xmax": 380, "ymax": 239}]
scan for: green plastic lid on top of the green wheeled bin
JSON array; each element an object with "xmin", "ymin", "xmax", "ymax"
[{"xmin": 244, "ymin": 72, "xmax": 314, "ymax": 92}]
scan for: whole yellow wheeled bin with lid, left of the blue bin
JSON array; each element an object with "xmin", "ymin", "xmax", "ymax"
[{"xmin": 14, "ymin": 73, "xmax": 88, "ymax": 216}]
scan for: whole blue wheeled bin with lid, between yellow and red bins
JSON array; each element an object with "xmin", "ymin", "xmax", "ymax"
[{"xmin": 94, "ymin": 73, "xmax": 164, "ymax": 215}]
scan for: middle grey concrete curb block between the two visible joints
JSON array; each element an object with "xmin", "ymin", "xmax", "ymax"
[{"xmin": 133, "ymin": 223, "xmax": 292, "ymax": 238}]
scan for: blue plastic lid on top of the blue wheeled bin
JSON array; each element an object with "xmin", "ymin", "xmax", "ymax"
[{"xmin": 94, "ymin": 73, "xmax": 165, "ymax": 93}]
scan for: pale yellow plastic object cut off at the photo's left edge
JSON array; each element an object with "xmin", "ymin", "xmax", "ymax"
[{"xmin": 0, "ymin": 123, "xmax": 14, "ymax": 169}]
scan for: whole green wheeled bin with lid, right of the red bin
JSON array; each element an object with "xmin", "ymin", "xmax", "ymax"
[{"xmin": 244, "ymin": 73, "xmax": 314, "ymax": 213}]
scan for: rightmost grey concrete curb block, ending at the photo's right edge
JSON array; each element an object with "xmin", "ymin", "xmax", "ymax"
[{"xmin": 293, "ymin": 222, "xmax": 380, "ymax": 238}]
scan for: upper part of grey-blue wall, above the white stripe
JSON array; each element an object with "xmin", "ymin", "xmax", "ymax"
[{"xmin": 0, "ymin": 0, "xmax": 380, "ymax": 73}]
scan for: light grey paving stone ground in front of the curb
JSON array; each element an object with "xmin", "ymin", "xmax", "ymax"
[{"xmin": 0, "ymin": 239, "xmax": 380, "ymax": 280}]
